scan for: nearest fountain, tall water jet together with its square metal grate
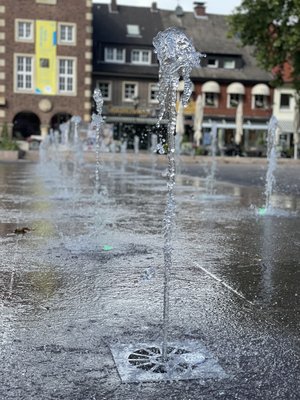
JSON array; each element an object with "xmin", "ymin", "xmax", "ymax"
[{"xmin": 111, "ymin": 28, "xmax": 226, "ymax": 382}]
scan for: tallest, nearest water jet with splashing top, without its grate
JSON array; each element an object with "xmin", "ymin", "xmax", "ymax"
[{"xmin": 153, "ymin": 27, "xmax": 201, "ymax": 362}]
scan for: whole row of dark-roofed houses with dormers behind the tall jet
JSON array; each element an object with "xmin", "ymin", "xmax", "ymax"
[{"xmin": 93, "ymin": 0, "xmax": 273, "ymax": 154}]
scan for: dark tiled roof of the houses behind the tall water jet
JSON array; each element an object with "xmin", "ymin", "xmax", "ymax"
[{"xmin": 93, "ymin": 4, "xmax": 272, "ymax": 83}]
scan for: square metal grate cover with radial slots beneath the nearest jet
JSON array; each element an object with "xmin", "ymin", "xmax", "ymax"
[{"xmin": 110, "ymin": 341, "xmax": 227, "ymax": 383}]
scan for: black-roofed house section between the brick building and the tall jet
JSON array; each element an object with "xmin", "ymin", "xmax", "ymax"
[{"xmin": 93, "ymin": 0, "xmax": 163, "ymax": 148}]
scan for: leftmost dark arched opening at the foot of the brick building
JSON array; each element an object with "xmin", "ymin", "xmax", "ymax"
[{"xmin": 12, "ymin": 112, "xmax": 41, "ymax": 140}]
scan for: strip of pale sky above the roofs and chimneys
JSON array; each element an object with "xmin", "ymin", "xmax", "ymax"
[{"xmin": 93, "ymin": 0, "xmax": 241, "ymax": 15}]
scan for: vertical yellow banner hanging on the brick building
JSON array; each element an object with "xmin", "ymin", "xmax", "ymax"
[{"xmin": 35, "ymin": 20, "xmax": 57, "ymax": 95}]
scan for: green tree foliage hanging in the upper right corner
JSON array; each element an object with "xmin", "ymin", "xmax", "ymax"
[{"xmin": 228, "ymin": 0, "xmax": 300, "ymax": 91}]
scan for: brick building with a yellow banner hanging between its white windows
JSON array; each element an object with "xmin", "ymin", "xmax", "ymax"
[{"xmin": 0, "ymin": 0, "xmax": 92, "ymax": 138}]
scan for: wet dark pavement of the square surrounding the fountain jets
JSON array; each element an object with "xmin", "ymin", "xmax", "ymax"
[{"xmin": 0, "ymin": 155, "xmax": 300, "ymax": 400}]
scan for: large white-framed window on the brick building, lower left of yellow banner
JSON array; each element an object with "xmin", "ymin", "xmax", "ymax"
[{"xmin": 15, "ymin": 55, "xmax": 33, "ymax": 91}]
